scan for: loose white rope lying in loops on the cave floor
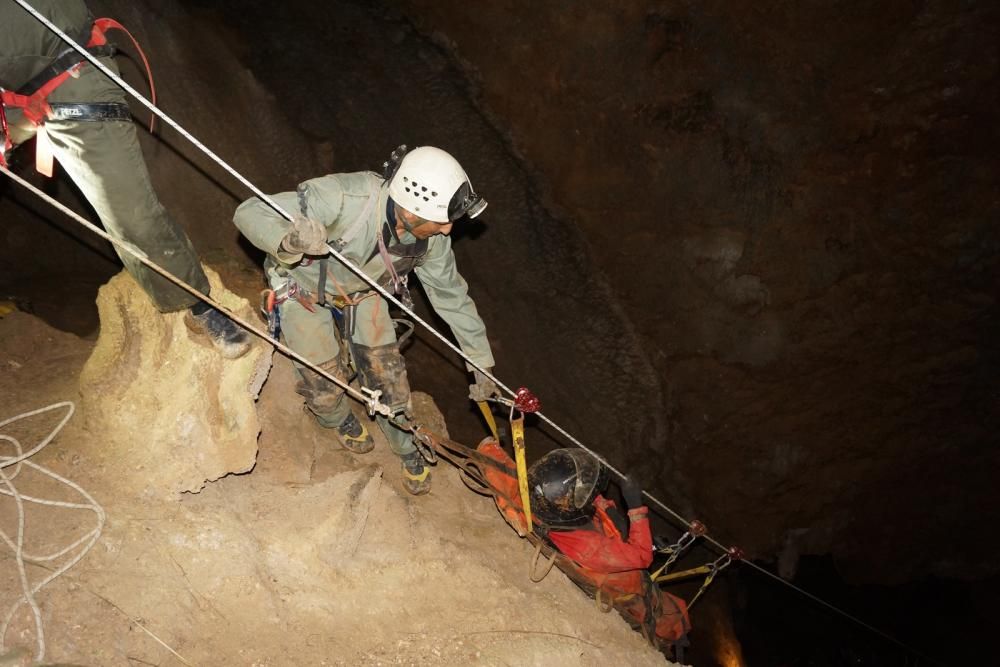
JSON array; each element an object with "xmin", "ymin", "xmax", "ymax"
[{"xmin": 0, "ymin": 401, "xmax": 106, "ymax": 662}]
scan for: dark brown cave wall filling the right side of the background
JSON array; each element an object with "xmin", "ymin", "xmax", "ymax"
[{"xmin": 395, "ymin": 0, "xmax": 1000, "ymax": 581}]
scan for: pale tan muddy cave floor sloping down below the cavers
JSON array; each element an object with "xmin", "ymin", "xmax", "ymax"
[{"xmin": 0, "ymin": 313, "xmax": 680, "ymax": 665}]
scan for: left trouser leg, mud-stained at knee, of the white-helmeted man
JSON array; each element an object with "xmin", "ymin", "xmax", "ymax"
[{"xmin": 278, "ymin": 298, "xmax": 351, "ymax": 428}]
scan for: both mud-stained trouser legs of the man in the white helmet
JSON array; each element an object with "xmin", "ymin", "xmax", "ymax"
[{"xmin": 272, "ymin": 292, "xmax": 416, "ymax": 457}]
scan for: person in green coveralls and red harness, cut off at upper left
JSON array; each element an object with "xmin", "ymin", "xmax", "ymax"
[{"xmin": 0, "ymin": 0, "xmax": 209, "ymax": 312}]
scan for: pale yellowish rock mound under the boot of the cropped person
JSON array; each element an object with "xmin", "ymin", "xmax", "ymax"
[{"xmin": 80, "ymin": 269, "xmax": 272, "ymax": 497}]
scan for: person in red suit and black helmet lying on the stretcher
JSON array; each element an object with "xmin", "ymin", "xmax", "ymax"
[{"xmin": 477, "ymin": 439, "xmax": 691, "ymax": 658}]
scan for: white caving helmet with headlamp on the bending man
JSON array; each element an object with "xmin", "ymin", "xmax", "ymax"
[{"xmin": 382, "ymin": 146, "xmax": 486, "ymax": 224}]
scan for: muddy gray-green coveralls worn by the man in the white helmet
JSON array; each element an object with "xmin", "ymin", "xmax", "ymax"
[{"xmin": 234, "ymin": 172, "xmax": 493, "ymax": 457}]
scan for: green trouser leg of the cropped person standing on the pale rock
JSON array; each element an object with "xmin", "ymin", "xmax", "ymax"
[{"xmin": 38, "ymin": 121, "xmax": 210, "ymax": 312}]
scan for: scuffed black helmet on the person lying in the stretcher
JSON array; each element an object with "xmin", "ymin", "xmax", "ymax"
[{"xmin": 528, "ymin": 449, "xmax": 608, "ymax": 526}]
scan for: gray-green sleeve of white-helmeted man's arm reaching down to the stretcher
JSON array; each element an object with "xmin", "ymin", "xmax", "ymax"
[{"xmin": 414, "ymin": 236, "xmax": 495, "ymax": 370}]
